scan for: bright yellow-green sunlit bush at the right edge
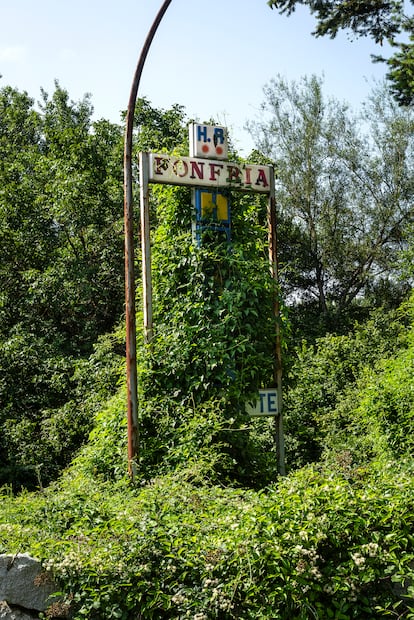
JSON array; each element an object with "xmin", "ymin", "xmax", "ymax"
[{"xmin": 321, "ymin": 298, "xmax": 414, "ymax": 464}]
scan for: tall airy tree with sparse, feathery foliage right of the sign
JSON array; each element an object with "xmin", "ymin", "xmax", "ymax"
[{"xmin": 250, "ymin": 77, "xmax": 414, "ymax": 336}]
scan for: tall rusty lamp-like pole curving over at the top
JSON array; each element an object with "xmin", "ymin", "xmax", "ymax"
[{"xmin": 124, "ymin": 0, "xmax": 172, "ymax": 481}]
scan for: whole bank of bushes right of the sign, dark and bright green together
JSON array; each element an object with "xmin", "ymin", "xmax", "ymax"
[{"xmin": 284, "ymin": 300, "xmax": 414, "ymax": 467}]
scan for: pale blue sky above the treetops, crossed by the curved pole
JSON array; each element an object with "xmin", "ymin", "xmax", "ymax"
[{"xmin": 0, "ymin": 0, "xmax": 392, "ymax": 154}]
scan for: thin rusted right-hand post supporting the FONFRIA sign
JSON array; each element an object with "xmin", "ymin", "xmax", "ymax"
[{"xmin": 268, "ymin": 168, "xmax": 286, "ymax": 476}]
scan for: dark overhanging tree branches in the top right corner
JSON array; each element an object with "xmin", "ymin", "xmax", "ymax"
[{"xmin": 268, "ymin": 0, "xmax": 414, "ymax": 105}]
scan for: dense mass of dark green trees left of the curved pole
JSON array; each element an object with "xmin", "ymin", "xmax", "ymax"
[{"xmin": 0, "ymin": 85, "xmax": 123, "ymax": 352}]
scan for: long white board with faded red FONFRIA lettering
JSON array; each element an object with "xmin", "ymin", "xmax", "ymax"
[{"xmin": 149, "ymin": 153, "xmax": 271, "ymax": 193}]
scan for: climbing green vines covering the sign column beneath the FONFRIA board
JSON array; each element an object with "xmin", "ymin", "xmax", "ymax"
[{"xmin": 141, "ymin": 182, "xmax": 275, "ymax": 406}]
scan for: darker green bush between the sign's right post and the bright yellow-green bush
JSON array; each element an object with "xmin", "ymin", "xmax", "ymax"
[{"xmin": 284, "ymin": 304, "xmax": 412, "ymax": 467}]
